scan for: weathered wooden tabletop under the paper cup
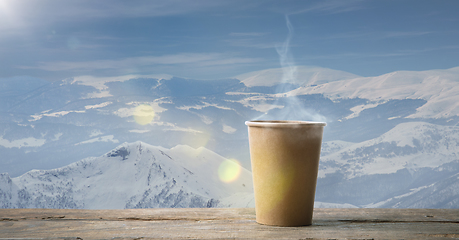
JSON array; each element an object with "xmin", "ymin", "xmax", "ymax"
[{"xmin": 0, "ymin": 208, "xmax": 459, "ymax": 239}]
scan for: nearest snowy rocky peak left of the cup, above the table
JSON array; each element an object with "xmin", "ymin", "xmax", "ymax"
[{"xmin": 0, "ymin": 142, "xmax": 253, "ymax": 209}]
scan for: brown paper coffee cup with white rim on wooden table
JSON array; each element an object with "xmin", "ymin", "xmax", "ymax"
[{"xmin": 245, "ymin": 121, "xmax": 326, "ymax": 227}]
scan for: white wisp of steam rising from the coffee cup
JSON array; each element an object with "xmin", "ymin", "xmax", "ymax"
[{"xmin": 257, "ymin": 16, "xmax": 326, "ymax": 122}]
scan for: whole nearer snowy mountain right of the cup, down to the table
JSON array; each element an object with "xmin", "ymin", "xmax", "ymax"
[{"xmin": 316, "ymin": 122, "xmax": 459, "ymax": 208}]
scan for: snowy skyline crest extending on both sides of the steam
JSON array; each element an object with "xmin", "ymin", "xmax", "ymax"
[{"xmin": 235, "ymin": 66, "xmax": 459, "ymax": 118}]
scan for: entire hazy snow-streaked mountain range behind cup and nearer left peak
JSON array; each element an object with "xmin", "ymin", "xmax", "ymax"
[{"xmin": 0, "ymin": 66, "xmax": 459, "ymax": 208}]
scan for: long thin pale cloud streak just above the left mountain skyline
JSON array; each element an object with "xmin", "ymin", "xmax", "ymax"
[{"xmin": 18, "ymin": 53, "xmax": 261, "ymax": 71}]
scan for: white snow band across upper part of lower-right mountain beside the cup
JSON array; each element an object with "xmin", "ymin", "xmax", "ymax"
[{"xmin": 319, "ymin": 122, "xmax": 459, "ymax": 179}]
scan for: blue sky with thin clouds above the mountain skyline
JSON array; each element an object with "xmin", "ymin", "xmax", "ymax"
[{"xmin": 0, "ymin": 0, "xmax": 459, "ymax": 81}]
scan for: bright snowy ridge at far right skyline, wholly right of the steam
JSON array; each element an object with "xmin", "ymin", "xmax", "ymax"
[{"xmin": 289, "ymin": 67, "xmax": 459, "ymax": 118}]
